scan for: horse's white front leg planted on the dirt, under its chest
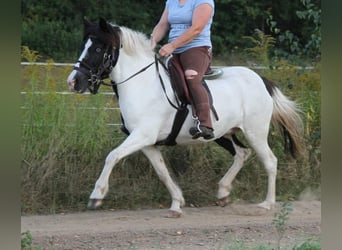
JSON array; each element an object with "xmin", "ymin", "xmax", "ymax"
[{"xmin": 142, "ymin": 146, "xmax": 185, "ymax": 218}]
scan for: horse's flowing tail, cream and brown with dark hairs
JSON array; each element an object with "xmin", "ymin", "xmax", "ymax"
[{"xmin": 262, "ymin": 78, "xmax": 303, "ymax": 158}]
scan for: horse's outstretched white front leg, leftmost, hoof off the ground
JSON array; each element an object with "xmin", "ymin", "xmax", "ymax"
[{"xmin": 88, "ymin": 132, "xmax": 153, "ymax": 209}]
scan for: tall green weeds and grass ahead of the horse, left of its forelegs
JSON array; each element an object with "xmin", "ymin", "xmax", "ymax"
[{"xmin": 21, "ymin": 46, "xmax": 123, "ymax": 212}]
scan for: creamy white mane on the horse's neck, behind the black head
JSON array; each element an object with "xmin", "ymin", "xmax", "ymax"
[{"xmin": 113, "ymin": 26, "xmax": 153, "ymax": 55}]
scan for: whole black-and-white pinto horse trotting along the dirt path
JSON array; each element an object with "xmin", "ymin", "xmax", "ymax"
[{"xmin": 67, "ymin": 18, "xmax": 302, "ymax": 217}]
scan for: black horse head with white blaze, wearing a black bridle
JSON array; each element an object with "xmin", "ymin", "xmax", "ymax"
[{"xmin": 67, "ymin": 18, "xmax": 121, "ymax": 94}]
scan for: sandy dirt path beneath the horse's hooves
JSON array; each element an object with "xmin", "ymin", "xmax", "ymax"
[{"xmin": 21, "ymin": 201, "xmax": 321, "ymax": 250}]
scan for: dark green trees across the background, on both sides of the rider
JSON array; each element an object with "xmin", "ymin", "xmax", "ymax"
[{"xmin": 21, "ymin": 0, "xmax": 321, "ymax": 62}]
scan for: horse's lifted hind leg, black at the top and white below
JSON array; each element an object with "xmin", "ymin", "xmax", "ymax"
[{"xmin": 216, "ymin": 134, "xmax": 251, "ymax": 206}]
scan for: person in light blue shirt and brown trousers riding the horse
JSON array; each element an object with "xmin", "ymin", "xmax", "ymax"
[{"xmin": 151, "ymin": 0, "xmax": 215, "ymax": 139}]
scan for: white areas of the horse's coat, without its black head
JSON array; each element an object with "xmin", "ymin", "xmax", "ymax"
[{"xmin": 68, "ymin": 22, "xmax": 300, "ymax": 216}]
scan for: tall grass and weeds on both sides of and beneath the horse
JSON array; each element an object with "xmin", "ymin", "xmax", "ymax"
[{"xmin": 21, "ymin": 48, "xmax": 320, "ymax": 213}]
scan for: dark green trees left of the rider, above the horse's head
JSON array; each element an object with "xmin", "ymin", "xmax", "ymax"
[{"xmin": 22, "ymin": 0, "xmax": 164, "ymax": 61}]
